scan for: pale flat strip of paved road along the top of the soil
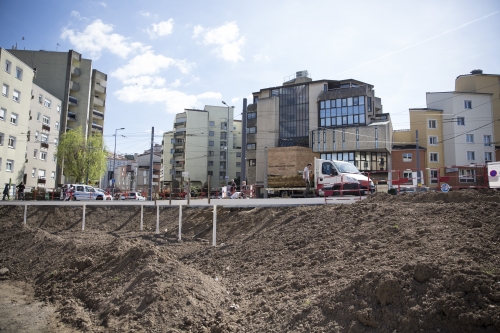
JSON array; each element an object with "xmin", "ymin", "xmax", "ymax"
[{"xmin": 0, "ymin": 196, "xmax": 366, "ymax": 207}]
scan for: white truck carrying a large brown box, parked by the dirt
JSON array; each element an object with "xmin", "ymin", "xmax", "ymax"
[{"xmin": 266, "ymin": 147, "xmax": 375, "ymax": 197}]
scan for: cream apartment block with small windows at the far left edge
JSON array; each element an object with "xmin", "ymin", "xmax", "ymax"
[{"xmin": 0, "ymin": 48, "xmax": 34, "ymax": 189}]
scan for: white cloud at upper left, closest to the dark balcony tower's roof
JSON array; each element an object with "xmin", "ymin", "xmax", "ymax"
[{"xmin": 61, "ymin": 20, "xmax": 150, "ymax": 59}]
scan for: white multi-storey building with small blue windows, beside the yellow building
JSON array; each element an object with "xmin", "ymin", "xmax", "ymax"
[{"xmin": 426, "ymin": 91, "xmax": 495, "ymax": 166}]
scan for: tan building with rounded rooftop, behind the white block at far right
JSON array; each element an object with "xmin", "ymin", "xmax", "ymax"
[{"xmin": 455, "ymin": 69, "xmax": 500, "ymax": 161}]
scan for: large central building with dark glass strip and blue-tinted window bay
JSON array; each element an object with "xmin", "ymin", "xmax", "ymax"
[{"xmin": 245, "ymin": 71, "xmax": 393, "ymax": 185}]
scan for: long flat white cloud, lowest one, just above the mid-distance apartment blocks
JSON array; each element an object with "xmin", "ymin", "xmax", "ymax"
[{"xmin": 115, "ymin": 86, "xmax": 221, "ymax": 114}]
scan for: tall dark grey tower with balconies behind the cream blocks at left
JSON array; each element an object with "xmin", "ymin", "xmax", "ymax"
[{"xmin": 10, "ymin": 49, "xmax": 107, "ymax": 183}]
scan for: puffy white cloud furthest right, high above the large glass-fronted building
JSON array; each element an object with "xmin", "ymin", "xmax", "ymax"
[{"xmin": 192, "ymin": 22, "xmax": 245, "ymax": 62}]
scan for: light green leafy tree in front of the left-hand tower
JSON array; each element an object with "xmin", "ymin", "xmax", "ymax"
[{"xmin": 56, "ymin": 127, "xmax": 107, "ymax": 183}]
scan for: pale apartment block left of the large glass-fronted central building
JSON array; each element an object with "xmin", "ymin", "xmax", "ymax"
[{"xmin": 163, "ymin": 105, "xmax": 242, "ymax": 187}]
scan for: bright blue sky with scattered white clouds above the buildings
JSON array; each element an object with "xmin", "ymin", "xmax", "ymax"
[{"xmin": 0, "ymin": 0, "xmax": 500, "ymax": 153}]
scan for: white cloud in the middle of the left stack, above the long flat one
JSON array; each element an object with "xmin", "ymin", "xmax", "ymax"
[{"xmin": 111, "ymin": 51, "xmax": 195, "ymax": 82}]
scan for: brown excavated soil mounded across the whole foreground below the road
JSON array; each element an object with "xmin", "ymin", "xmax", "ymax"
[{"xmin": 0, "ymin": 190, "xmax": 500, "ymax": 333}]
